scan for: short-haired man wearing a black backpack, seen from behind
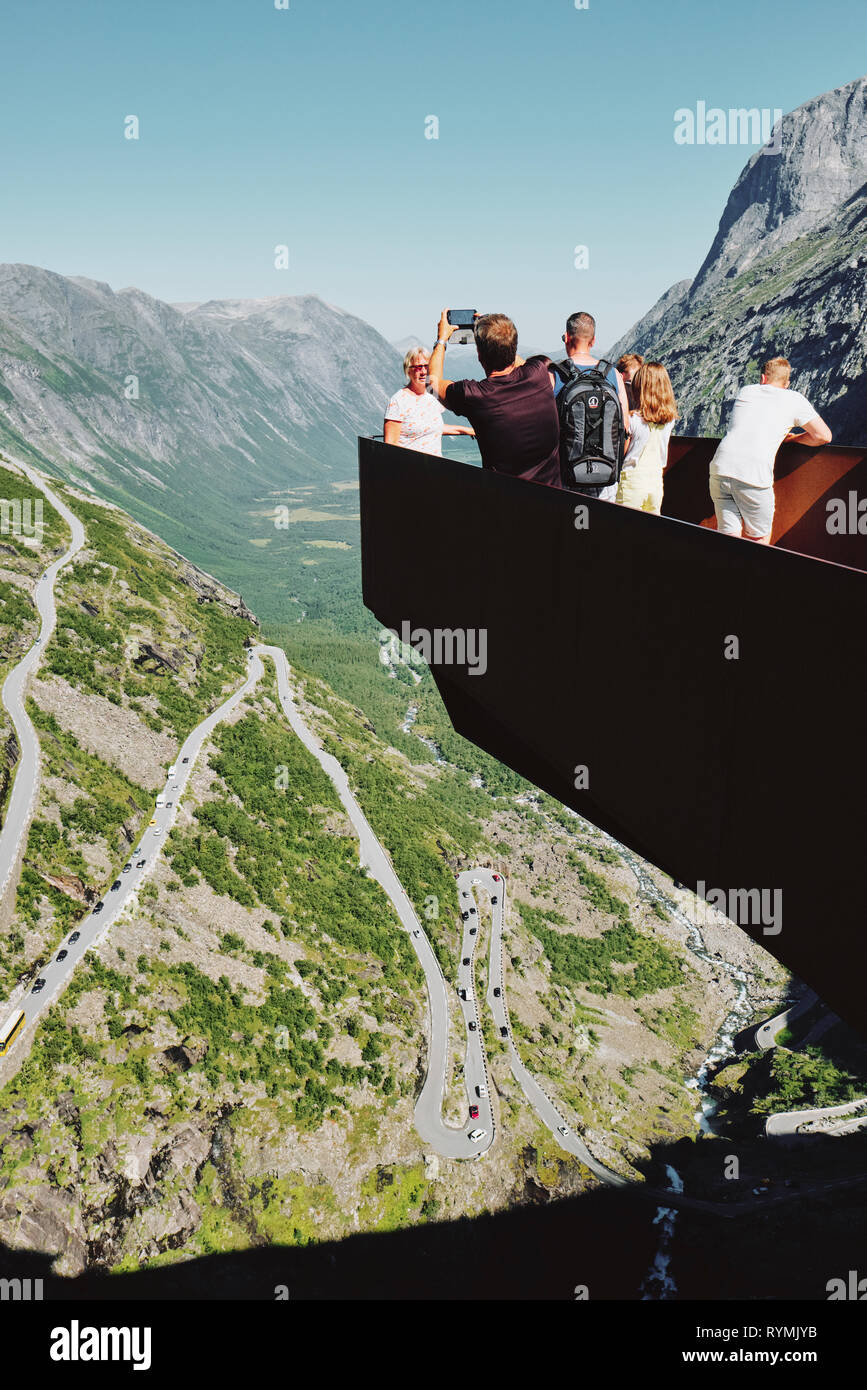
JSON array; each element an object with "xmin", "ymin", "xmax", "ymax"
[{"xmin": 549, "ymin": 313, "xmax": 629, "ymax": 502}]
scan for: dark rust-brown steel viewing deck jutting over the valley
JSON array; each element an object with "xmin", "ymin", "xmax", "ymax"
[{"xmin": 358, "ymin": 439, "xmax": 867, "ymax": 1033}]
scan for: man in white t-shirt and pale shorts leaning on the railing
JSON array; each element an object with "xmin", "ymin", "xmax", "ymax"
[{"xmin": 710, "ymin": 357, "xmax": 831, "ymax": 545}]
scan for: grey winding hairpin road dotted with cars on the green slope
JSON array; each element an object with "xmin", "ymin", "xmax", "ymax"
[{"xmin": 0, "ymin": 572, "xmax": 850, "ymax": 1218}]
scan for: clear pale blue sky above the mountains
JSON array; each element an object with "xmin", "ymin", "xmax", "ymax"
[{"xmin": 0, "ymin": 0, "xmax": 863, "ymax": 348}]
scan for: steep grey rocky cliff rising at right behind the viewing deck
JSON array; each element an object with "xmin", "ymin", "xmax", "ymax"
[{"xmin": 611, "ymin": 78, "xmax": 867, "ymax": 443}]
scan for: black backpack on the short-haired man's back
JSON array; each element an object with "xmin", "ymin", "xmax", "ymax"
[{"xmin": 552, "ymin": 357, "xmax": 624, "ymax": 492}]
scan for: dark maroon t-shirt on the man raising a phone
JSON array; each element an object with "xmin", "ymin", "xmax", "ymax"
[{"xmin": 445, "ymin": 357, "xmax": 560, "ymax": 488}]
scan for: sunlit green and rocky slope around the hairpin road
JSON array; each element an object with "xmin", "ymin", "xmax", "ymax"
[{"xmin": 0, "ymin": 455, "xmax": 778, "ymax": 1273}]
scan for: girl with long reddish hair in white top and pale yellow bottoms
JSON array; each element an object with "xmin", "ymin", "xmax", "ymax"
[{"xmin": 617, "ymin": 361, "xmax": 678, "ymax": 516}]
